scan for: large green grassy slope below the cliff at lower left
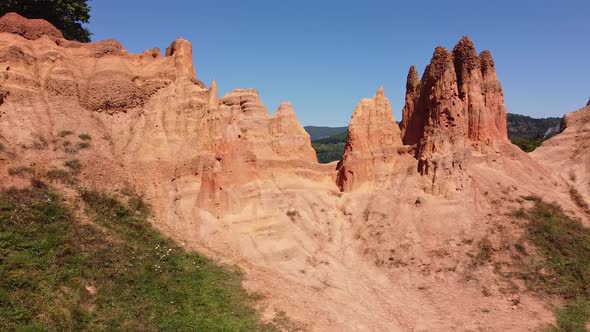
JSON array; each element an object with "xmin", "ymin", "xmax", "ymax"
[{"xmin": 0, "ymin": 188, "xmax": 273, "ymax": 331}]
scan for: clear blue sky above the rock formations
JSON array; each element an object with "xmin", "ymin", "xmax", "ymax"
[{"xmin": 89, "ymin": 0, "xmax": 590, "ymax": 126}]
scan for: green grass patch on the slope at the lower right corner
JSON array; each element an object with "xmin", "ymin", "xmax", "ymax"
[{"xmin": 525, "ymin": 198, "xmax": 590, "ymax": 331}]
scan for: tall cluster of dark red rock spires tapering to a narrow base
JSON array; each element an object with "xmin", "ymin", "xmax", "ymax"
[{"xmin": 401, "ymin": 37, "xmax": 508, "ymax": 191}]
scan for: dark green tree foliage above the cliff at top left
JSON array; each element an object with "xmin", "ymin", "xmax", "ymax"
[{"xmin": 0, "ymin": 0, "xmax": 92, "ymax": 42}]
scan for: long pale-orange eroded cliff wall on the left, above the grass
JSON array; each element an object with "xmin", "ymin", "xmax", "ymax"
[{"xmin": 0, "ymin": 15, "xmax": 317, "ymax": 214}]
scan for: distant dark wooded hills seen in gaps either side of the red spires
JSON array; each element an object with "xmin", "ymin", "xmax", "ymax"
[{"xmin": 305, "ymin": 113, "xmax": 561, "ymax": 163}]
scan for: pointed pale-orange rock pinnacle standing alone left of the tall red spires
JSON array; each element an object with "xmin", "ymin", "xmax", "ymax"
[{"xmin": 337, "ymin": 88, "xmax": 402, "ymax": 191}]
